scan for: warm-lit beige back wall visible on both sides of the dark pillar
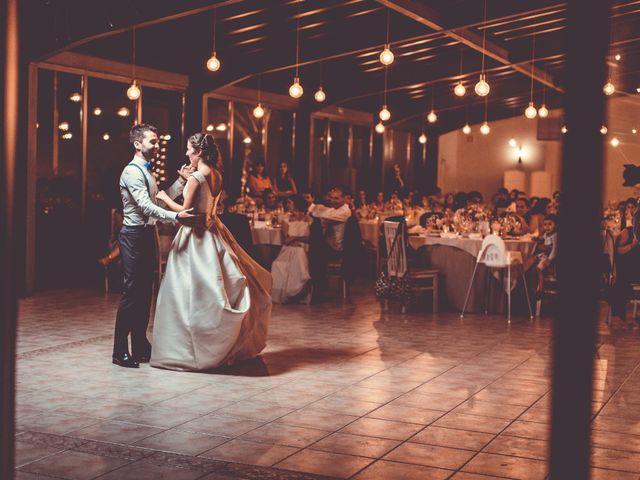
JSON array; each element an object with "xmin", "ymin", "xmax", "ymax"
[{"xmin": 438, "ymin": 95, "xmax": 640, "ymax": 203}]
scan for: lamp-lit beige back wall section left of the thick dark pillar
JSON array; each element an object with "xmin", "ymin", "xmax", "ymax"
[{"xmin": 438, "ymin": 111, "xmax": 561, "ymax": 199}]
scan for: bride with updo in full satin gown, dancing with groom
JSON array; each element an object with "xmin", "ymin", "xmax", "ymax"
[{"xmin": 150, "ymin": 133, "xmax": 271, "ymax": 370}]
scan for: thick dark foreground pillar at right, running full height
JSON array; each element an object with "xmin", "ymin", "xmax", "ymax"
[{"xmin": 550, "ymin": 0, "xmax": 610, "ymax": 480}]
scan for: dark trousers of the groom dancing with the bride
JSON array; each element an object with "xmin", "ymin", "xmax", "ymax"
[{"xmin": 113, "ymin": 225, "xmax": 155, "ymax": 357}]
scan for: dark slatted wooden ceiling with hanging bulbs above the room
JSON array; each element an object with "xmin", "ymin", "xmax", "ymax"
[{"xmin": 27, "ymin": 0, "xmax": 640, "ymax": 132}]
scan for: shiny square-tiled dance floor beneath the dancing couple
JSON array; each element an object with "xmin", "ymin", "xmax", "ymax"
[{"xmin": 11, "ymin": 288, "xmax": 640, "ymax": 480}]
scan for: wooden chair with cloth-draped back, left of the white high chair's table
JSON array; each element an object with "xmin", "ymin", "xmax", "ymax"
[{"xmin": 383, "ymin": 217, "xmax": 440, "ymax": 313}]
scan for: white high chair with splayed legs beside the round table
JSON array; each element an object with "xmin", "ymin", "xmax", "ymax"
[{"xmin": 460, "ymin": 235, "xmax": 533, "ymax": 323}]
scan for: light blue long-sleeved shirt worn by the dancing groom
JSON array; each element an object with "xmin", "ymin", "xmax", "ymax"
[{"xmin": 120, "ymin": 156, "xmax": 184, "ymax": 226}]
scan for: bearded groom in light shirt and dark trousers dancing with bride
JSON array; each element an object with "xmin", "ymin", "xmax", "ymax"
[{"xmin": 112, "ymin": 123, "xmax": 195, "ymax": 368}]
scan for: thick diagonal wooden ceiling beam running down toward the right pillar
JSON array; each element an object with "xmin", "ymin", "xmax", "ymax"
[{"xmin": 376, "ymin": 0, "xmax": 563, "ymax": 92}]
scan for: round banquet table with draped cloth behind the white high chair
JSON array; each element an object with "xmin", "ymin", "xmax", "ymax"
[{"xmin": 409, "ymin": 234, "xmax": 536, "ymax": 313}]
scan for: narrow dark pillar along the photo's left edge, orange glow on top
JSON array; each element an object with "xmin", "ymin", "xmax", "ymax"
[{"xmin": 0, "ymin": 0, "xmax": 20, "ymax": 478}]
